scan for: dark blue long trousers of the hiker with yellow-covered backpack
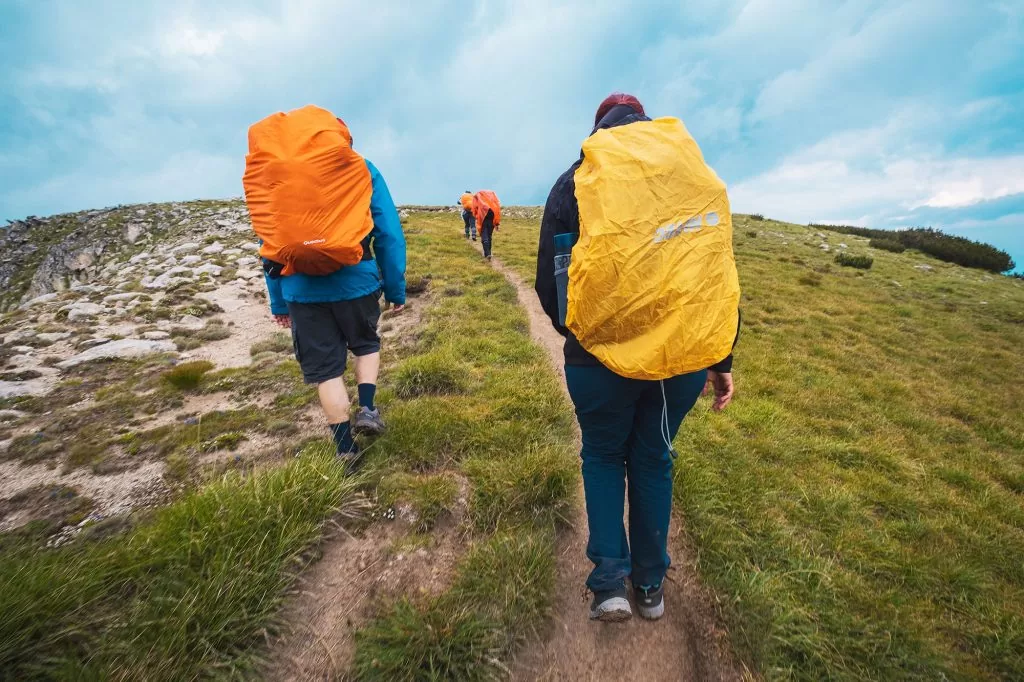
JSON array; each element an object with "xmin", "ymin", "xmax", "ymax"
[{"xmin": 565, "ymin": 365, "xmax": 708, "ymax": 592}]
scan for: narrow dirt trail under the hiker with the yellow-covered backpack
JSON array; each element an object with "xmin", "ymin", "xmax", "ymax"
[{"xmin": 483, "ymin": 248, "xmax": 754, "ymax": 682}]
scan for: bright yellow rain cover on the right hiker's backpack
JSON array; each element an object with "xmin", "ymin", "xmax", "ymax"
[{"xmin": 565, "ymin": 118, "xmax": 739, "ymax": 379}]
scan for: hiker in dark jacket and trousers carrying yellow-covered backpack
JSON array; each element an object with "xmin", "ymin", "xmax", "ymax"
[{"xmin": 536, "ymin": 94, "xmax": 739, "ymax": 621}]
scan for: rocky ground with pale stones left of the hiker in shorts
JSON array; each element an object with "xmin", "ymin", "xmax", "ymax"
[{"xmin": 0, "ymin": 202, "xmax": 331, "ymax": 544}]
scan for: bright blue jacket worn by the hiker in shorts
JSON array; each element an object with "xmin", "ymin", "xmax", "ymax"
[{"xmin": 264, "ymin": 161, "xmax": 406, "ymax": 315}]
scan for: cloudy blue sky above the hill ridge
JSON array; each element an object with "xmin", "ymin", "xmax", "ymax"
[{"xmin": 0, "ymin": 0, "xmax": 1024, "ymax": 267}]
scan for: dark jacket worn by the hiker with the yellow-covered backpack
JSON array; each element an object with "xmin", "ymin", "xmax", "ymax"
[{"xmin": 534, "ymin": 104, "xmax": 738, "ymax": 372}]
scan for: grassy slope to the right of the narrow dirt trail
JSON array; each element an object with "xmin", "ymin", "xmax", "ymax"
[{"xmin": 495, "ymin": 210, "xmax": 1024, "ymax": 680}]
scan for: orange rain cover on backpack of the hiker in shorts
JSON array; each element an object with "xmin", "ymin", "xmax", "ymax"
[{"xmin": 242, "ymin": 104, "xmax": 374, "ymax": 275}]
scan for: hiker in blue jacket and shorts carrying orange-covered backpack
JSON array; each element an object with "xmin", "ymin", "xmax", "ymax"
[{"xmin": 243, "ymin": 105, "xmax": 406, "ymax": 468}]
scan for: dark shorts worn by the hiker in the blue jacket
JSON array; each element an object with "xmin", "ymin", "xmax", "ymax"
[{"xmin": 288, "ymin": 292, "xmax": 381, "ymax": 384}]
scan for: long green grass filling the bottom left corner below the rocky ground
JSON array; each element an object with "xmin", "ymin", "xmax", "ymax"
[{"xmin": 0, "ymin": 440, "xmax": 361, "ymax": 680}]
